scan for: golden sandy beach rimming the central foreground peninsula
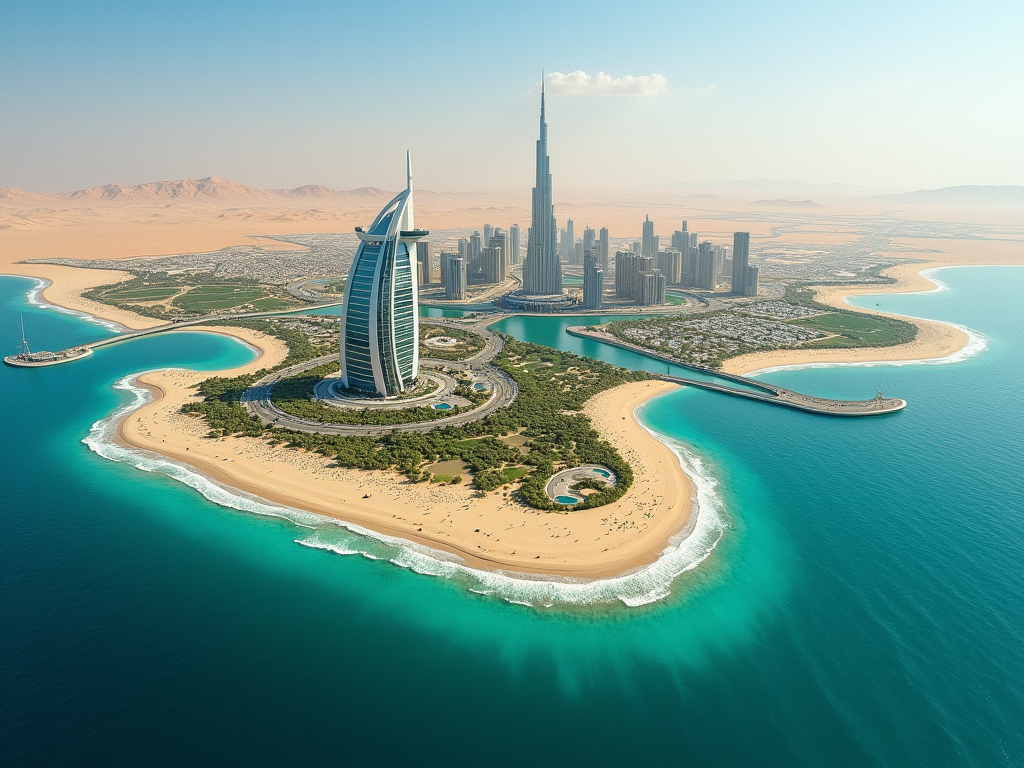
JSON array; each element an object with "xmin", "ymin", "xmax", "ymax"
[{"xmin": 118, "ymin": 329, "xmax": 692, "ymax": 578}]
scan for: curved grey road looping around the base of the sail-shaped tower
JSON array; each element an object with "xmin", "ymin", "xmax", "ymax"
[{"xmin": 242, "ymin": 317, "xmax": 519, "ymax": 436}]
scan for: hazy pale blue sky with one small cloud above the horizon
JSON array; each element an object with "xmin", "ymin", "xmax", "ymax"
[{"xmin": 0, "ymin": 0, "xmax": 1024, "ymax": 196}]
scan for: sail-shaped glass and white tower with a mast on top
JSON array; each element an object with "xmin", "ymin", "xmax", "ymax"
[{"xmin": 340, "ymin": 154, "xmax": 429, "ymax": 397}]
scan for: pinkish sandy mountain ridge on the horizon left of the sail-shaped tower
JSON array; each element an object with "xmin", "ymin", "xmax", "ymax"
[{"xmin": 0, "ymin": 176, "xmax": 393, "ymax": 204}]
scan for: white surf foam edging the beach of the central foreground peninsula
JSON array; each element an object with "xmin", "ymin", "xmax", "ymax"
[{"xmin": 88, "ymin": 375, "xmax": 729, "ymax": 607}]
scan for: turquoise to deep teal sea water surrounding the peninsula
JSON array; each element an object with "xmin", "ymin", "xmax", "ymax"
[{"xmin": 0, "ymin": 268, "xmax": 1024, "ymax": 766}]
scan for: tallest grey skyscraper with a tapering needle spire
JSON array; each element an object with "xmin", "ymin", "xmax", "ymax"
[{"xmin": 522, "ymin": 83, "xmax": 562, "ymax": 296}]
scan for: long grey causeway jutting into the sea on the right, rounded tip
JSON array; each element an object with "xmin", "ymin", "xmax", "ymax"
[{"xmin": 565, "ymin": 326, "xmax": 906, "ymax": 416}]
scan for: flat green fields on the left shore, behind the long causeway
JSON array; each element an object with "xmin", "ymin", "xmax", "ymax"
[{"xmin": 82, "ymin": 272, "xmax": 300, "ymax": 321}]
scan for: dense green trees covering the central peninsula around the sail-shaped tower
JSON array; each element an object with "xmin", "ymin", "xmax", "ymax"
[{"xmin": 182, "ymin": 333, "xmax": 646, "ymax": 511}]
